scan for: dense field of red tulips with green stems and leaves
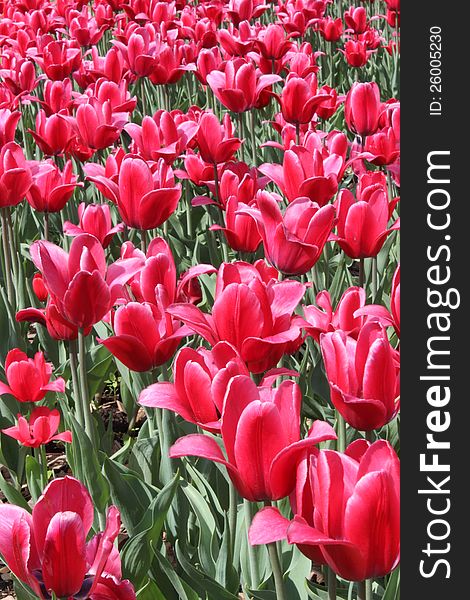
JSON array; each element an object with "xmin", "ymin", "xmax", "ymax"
[{"xmin": 0, "ymin": 0, "xmax": 400, "ymax": 600}]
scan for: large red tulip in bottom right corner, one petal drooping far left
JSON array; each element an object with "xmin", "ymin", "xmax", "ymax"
[{"xmin": 249, "ymin": 440, "xmax": 400, "ymax": 581}]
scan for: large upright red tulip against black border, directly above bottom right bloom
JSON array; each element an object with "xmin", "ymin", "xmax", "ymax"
[{"xmin": 320, "ymin": 321, "xmax": 400, "ymax": 431}]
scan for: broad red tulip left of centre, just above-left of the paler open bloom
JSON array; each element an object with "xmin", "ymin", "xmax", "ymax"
[{"xmin": 98, "ymin": 298, "xmax": 191, "ymax": 372}]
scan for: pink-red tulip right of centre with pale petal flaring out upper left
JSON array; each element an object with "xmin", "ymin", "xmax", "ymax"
[{"xmin": 242, "ymin": 192, "xmax": 335, "ymax": 275}]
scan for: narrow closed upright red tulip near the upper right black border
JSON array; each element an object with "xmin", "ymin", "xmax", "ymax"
[{"xmin": 344, "ymin": 82, "xmax": 382, "ymax": 137}]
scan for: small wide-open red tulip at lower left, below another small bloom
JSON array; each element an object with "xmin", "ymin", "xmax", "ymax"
[{"xmin": 2, "ymin": 406, "xmax": 72, "ymax": 448}]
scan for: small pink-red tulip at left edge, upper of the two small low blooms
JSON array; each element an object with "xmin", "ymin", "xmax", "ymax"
[{"xmin": 0, "ymin": 348, "xmax": 65, "ymax": 402}]
